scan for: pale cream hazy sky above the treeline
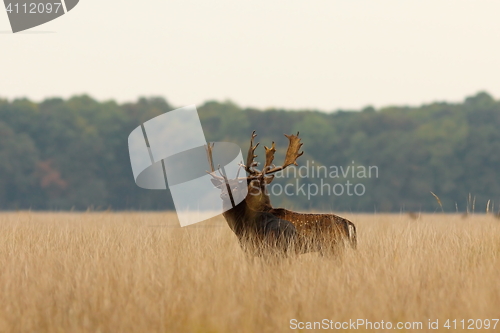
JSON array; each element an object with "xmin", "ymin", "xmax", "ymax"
[{"xmin": 0, "ymin": 0, "xmax": 500, "ymax": 111}]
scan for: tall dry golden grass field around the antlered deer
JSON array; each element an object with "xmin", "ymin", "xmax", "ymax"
[{"xmin": 0, "ymin": 212, "xmax": 500, "ymax": 333}]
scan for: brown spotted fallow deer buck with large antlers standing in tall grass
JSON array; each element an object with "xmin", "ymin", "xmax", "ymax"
[{"xmin": 207, "ymin": 131, "xmax": 357, "ymax": 254}]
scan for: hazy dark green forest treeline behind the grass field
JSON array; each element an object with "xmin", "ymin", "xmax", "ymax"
[{"xmin": 0, "ymin": 92, "xmax": 500, "ymax": 212}]
